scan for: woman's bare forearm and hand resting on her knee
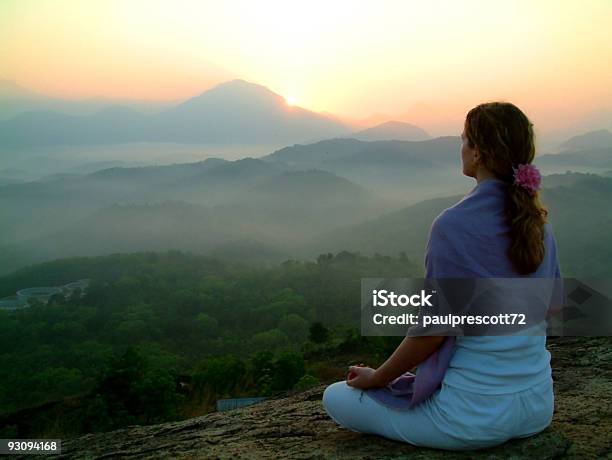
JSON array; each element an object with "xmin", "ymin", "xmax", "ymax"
[{"xmin": 347, "ymin": 336, "xmax": 446, "ymax": 389}]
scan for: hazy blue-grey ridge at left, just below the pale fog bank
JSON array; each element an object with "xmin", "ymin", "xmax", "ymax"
[{"xmin": 0, "ymin": 158, "xmax": 283, "ymax": 244}]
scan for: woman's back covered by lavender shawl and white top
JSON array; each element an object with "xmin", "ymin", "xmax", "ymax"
[{"xmin": 425, "ymin": 179, "xmax": 559, "ymax": 394}]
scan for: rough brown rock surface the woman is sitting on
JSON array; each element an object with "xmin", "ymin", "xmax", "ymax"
[{"xmin": 40, "ymin": 338, "xmax": 612, "ymax": 460}]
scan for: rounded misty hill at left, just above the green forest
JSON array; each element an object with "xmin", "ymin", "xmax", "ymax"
[{"xmin": 0, "ymin": 201, "xmax": 298, "ymax": 272}]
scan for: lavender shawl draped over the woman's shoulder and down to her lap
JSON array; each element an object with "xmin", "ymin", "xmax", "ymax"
[{"xmin": 365, "ymin": 179, "xmax": 512, "ymax": 410}]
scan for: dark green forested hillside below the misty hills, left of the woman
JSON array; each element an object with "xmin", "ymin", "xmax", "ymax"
[{"xmin": 0, "ymin": 251, "xmax": 422, "ymax": 437}]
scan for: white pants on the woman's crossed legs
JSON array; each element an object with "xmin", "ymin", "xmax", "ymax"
[{"xmin": 323, "ymin": 379, "xmax": 554, "ymax": 450}]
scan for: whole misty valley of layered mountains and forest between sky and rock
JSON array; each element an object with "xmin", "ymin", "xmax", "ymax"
[{"xmin": 0, "ymin": 80, "xmax": 612, "ymax": 438}]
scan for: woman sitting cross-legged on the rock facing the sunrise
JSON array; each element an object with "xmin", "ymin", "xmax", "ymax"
[{"xmin": 323, "ymin": 102, "xmax": 560, "ymax": 450}]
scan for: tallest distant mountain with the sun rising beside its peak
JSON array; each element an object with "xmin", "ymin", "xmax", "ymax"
[{"xmin": 0, "ymin": 80, "xmax": 347, "ymax": 148}]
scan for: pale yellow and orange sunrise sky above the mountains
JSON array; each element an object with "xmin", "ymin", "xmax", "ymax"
[{"xmin": 0, "ymin": 0, "xmax": 612, "ymax": 134}]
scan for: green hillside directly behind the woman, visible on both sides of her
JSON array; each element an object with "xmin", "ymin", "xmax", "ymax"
[{"xmin": 303, "ymin": 173, "xmax": 612, "ymax": 276}]
